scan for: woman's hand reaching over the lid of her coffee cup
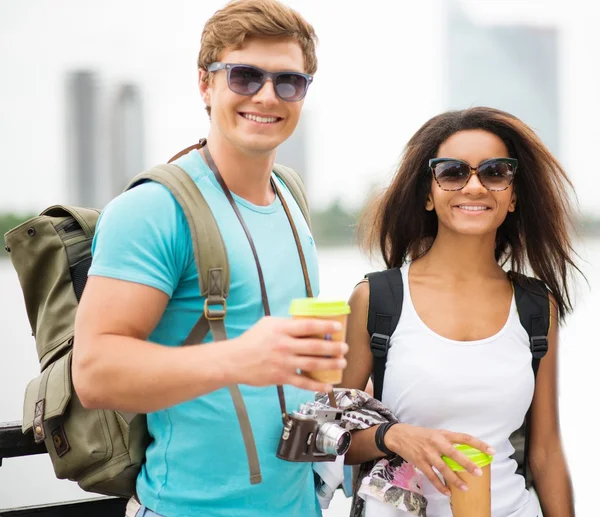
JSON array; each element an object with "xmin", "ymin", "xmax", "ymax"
[{"xmin": 384, "ymin": 424, "xmax": 496, "ymax": 496}]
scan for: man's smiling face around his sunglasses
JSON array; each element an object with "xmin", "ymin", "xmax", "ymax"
[{"xmin": 200, "ymin": 38, "xmax": 304, "ymax": 154}]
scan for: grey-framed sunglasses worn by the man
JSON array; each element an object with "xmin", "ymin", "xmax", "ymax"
[{"xmin": 206, "ymin": 62, "xmax": 313, "ymax": 102}]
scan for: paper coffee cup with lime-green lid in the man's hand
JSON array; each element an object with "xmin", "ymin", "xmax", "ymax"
[{"xmin": 289, "ymin": 298, "xmax": 350, "ymax": 384}]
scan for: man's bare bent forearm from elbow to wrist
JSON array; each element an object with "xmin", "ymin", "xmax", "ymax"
[{"xmin": 73, "ymin": 335, "xmax": 235, "ymax": 413}]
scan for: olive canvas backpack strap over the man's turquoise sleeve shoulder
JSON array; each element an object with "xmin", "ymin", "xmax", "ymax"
[{"xmin": 125, "ymin": 164, "xmax": 262, "ymax": 484}]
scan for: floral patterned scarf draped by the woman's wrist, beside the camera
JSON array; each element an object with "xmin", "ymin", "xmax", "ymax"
[{"xmin": 315, "ymin": 388, "xmax": 427, "ymax": 517}]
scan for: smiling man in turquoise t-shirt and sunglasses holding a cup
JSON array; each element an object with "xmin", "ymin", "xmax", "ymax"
[{"xmin": 73, "ymin": 0, "xmax": 347, "ymax": 517}]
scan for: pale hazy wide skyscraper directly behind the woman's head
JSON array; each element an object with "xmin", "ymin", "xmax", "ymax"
[{"xmin": 442, "ymin": 0, "xmax": 561, "ymax": 156}]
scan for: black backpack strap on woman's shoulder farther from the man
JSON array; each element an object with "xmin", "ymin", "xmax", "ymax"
[{"xmin": 511, "ymin": 273, "xmax": 550, "ymax": 375}]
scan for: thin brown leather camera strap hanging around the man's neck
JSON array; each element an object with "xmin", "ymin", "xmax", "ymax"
[{"xmin": 202, "ymin": 141, "xmax": 313, "ymax": 425}]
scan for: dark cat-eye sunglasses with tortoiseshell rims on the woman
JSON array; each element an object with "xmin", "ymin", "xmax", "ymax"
[{"xmin": 429, "ymin": 158, "xmax": 519, "ymax": 191}]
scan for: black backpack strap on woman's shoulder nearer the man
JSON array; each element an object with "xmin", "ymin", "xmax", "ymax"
[{"xmin": 365, "ymin": 268, "xmax": 404, "ymax": 400}]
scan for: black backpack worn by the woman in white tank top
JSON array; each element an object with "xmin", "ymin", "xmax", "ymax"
[{"xmin": 365, "ymin": 268, "xmax": 550, "ymax": 488}]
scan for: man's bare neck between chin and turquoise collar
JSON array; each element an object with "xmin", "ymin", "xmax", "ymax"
[{"xmin": 201, "ymin": 131, "xmax": 275, "ymax": 206}]
